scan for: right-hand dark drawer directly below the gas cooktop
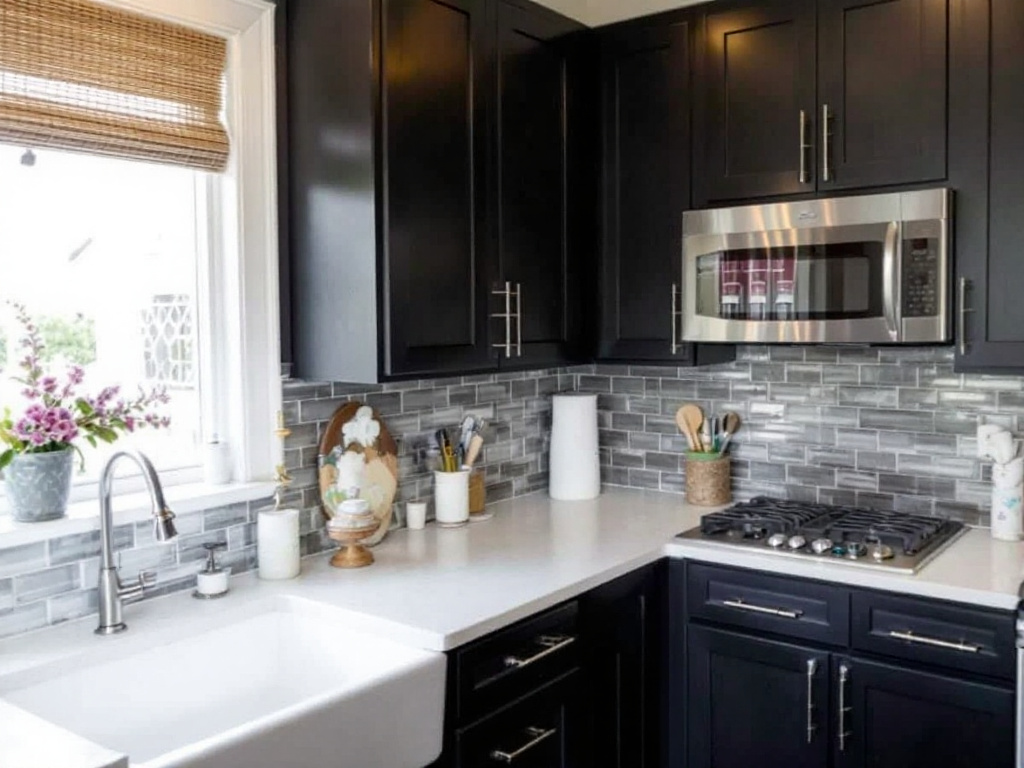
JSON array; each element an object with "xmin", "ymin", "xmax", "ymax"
[{"xmin": 852, "ymin": 592, "xmax": 1016, "ymax": 679}]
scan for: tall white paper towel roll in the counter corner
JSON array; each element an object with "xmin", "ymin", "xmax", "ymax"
[{"xmin": 548, "ymin": 392, "xmax": 601, "ymax": 502}]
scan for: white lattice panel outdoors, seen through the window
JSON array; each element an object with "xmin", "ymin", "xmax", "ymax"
[{"xmin": 142, "ymin": 294, "xmax": 196, "ymax": 388}]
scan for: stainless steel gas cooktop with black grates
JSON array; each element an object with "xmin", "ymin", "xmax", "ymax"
[{"xmin": 677, "ymin": 496, "xmax": 967, "ymax": 573}]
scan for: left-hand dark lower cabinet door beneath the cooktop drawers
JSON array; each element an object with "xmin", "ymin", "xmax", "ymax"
[{"xmin": 686, "ymin": 624, "xmax": 829, "ymax": 768}]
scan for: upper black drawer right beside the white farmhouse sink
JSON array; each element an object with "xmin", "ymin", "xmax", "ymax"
[{"xmin": 456, "ymin": 601, "xmax": 581, "ymax": 722}]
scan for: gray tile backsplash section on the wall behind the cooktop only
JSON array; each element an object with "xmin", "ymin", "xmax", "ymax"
[{"xmin": 578, "ymin": 346, "xmax": 1024, "ymax": 524}]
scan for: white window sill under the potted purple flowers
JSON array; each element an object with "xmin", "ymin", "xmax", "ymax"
[{"xmin": 0, "ymin": 482, "xmax": 276, "ymax": 549}]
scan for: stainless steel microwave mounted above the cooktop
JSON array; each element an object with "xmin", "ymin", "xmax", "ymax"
[{"xmin": 681, "ymin": 189, "xmax": 952, "ymax": 344}]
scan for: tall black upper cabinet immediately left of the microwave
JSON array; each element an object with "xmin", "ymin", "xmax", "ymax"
[{"xmin": 598, "ymin": 13, "xmax": 732, "ymax": 365}]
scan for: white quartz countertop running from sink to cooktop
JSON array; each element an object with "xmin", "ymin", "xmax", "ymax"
[{"xmin": 0, "ymin": 488, "xmax": 1024, "ymax": 768}]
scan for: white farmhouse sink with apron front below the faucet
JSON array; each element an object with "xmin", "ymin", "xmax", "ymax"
[{"xmin": 0, "ymin": 600, "xmax": 444, "ymax": 768}]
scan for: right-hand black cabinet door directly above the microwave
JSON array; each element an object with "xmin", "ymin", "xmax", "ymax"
[{"xmin": 815, "ymin": 0, "xmax": 948, "ymax": 190}]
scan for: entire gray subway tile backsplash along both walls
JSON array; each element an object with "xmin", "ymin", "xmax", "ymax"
[{"xmin": 0, "ymin": 346, "xmax": 1024, "ymax": 637}]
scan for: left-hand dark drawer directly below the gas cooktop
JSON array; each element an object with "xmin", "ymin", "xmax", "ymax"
[{"xmin": 686, "ymin": 564, "xmax": 850, "ymax": 645}]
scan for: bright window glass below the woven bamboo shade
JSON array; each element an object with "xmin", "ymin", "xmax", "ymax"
[{"xmin": 0, "ymin": 144, "xmax": 206, "ymax": 479}]
